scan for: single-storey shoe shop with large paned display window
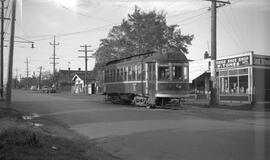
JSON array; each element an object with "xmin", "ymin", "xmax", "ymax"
[{"xmin": 216, "ymin": 51, "xmax": 270, "ymax": 103}]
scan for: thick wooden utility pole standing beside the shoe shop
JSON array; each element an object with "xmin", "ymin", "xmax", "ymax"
[{"xmin": 206, "ymin": 0, "xmax": 231, "ymax": 105}]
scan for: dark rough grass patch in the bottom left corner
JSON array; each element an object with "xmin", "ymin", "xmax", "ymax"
[{"xmin": 0, "ymin": 128, "xmax": 92, "ymax": 160}]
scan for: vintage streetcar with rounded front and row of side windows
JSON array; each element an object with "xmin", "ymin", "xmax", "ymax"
[{"xmin": 104, "ymin": 50, "xmax": 189, "ymax": 106}]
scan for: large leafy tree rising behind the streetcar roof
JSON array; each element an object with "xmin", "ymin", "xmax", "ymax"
[{"xmin": 95, "ymin": 6, "xmax": 194, "ymax": 64}]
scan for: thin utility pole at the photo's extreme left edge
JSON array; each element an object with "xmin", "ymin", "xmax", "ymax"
[{"xmin": 0, "ymin": 0, "xmax": 5, "ymax": 99}]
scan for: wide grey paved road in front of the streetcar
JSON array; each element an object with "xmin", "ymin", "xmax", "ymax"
[{"xmin": 9, "ymin": 91, "xmax": 270, "ymax": 160}]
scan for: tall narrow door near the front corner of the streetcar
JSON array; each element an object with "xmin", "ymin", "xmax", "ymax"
[{"xmin": 147, "ymin": 62, "xmax": 156, "ymax": 104}]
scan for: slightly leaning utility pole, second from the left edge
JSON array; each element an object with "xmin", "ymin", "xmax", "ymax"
[{"xmin": 6, "ymin": 0, "xmax": 17, "ymax": 105}]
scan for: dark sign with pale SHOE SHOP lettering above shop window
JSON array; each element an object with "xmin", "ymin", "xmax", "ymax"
[{"xmin": 216, "ymin": 56, "xmax": 250, "ymax": 68}]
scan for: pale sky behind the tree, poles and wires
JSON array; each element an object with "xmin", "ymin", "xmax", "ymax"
[{"xmin": 2, "ymin": 0, "xmax": 270, "ymax": 77}]
